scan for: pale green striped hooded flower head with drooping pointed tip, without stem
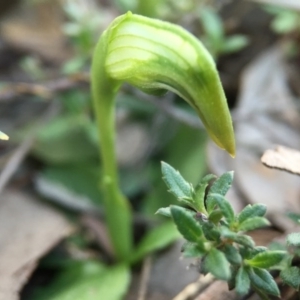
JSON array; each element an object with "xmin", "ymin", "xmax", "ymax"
[{"xmin": 95, "ymin": 12, "xmax": 235, "ymax": 156}]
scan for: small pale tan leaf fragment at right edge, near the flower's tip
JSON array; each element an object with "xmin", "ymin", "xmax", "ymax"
[{"xmin": 261, "ymin": 146, "xmax": 300, "ymax": 175}]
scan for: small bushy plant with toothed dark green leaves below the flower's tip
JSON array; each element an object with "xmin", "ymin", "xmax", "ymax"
[{"xmin": 157, "ymin": 163, "xmax": 288, "ymax": 299}]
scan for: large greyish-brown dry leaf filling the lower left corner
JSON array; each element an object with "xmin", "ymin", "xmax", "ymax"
[{"xmin": 0, "ymin": 191, "xmax": 72, "ymax": 300}]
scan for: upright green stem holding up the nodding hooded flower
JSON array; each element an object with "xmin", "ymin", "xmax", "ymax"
[{"xmin": 91, "ymin": 36, "xmax": 132, "ymax": 261}]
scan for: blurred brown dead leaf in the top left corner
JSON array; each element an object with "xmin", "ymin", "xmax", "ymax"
[{"xmin": 0, "ymin": 1, "xmax": 70, "ymax": 62}]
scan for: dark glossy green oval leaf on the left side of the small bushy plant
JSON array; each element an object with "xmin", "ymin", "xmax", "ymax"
[{"xmin": 171, "ymin": 205, "xmax": 203, "ymax": 243}]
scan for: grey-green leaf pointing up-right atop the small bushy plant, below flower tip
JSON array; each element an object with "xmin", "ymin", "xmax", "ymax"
[{"xmin": 206, "ymin": 171, "xmax": 234, "ymax": 213}]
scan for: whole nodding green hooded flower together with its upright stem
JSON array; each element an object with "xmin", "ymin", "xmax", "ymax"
[{"xmin": 92, "ymin": 12, "xmax": 235, "ymax": 260}]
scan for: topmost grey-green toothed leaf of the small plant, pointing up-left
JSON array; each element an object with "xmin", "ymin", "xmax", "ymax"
[{"xmin": 161, "ymin": 162, "xmax": 193, "ymax": 200}]
